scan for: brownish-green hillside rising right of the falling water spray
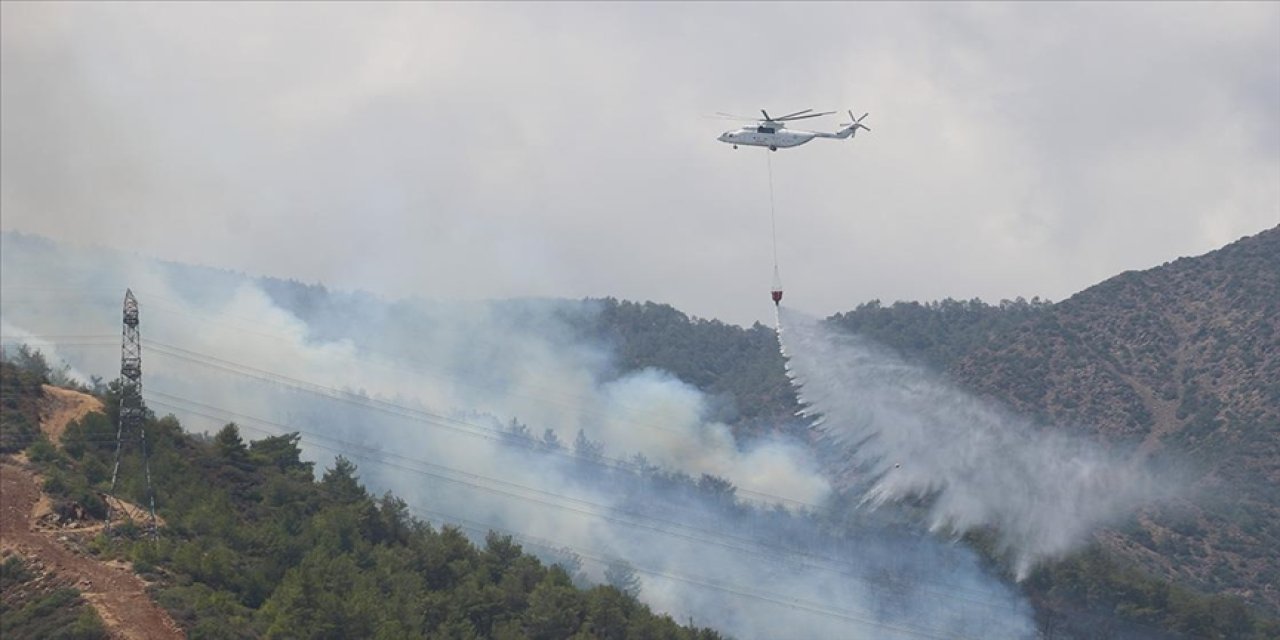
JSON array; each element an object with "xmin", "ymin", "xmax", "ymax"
[{"xmin": 832, "ymin": 228, "xmax": 1280, "ymax": 611}]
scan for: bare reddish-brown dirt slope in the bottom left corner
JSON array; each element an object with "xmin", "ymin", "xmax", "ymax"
[{"xmin": 0, "ymin": 461, "xmax": 184, "ymax": 640}]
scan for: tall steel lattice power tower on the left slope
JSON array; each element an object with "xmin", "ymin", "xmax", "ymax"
[{"xmin": 106, "ymin": 289, "xmax": 156, "ymax": 538}]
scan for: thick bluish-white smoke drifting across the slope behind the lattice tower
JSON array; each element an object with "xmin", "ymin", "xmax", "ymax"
[{"xmin": 0, "ymin": 234, "xmax": 1033, "ymax": 639}]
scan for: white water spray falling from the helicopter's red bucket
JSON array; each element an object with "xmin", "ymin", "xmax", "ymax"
[{"xmin": 780, "ymin": 308, "xmax": 1176, "ymax": 580}]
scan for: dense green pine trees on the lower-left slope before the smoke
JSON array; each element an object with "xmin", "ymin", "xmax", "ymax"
[{"xmin": 0, "ymin": 364, "xmax": 719, "ymax": 640}]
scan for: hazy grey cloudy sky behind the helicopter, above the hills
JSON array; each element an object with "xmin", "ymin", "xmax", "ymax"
[{"xmin": 0, "ymin": 3, "xmax": 1280, "ymax": 323}]
